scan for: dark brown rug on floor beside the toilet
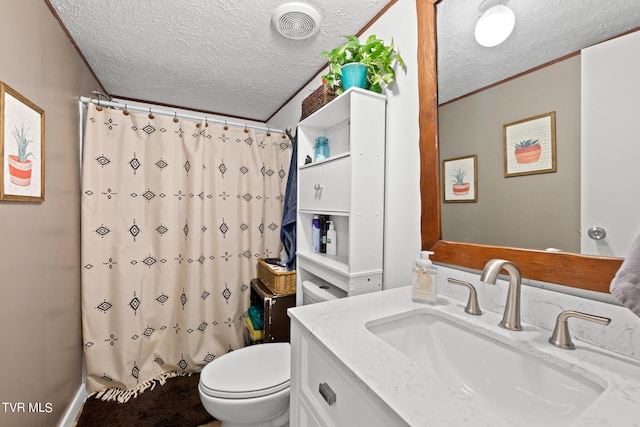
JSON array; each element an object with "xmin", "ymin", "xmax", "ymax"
[{"xmin": 74, "ymin": 374, "xmax": 220, "ymax": 427}]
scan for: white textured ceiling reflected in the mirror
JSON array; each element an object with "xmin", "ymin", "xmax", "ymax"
[{"xmin": 436, "ymin": 0, "xmax": 640, "ymax": 103}]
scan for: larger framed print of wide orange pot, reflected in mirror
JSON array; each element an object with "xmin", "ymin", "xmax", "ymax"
[{"xmin": 502, "ymin": 111, "xmax": 556, "ymax": 177}]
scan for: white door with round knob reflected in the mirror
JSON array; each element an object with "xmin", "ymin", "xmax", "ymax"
[{"xmin": 580, "ymin": 31, "xmax": 640, "ymax": 257}]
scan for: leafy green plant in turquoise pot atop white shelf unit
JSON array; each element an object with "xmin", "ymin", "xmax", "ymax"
[{"xmin": 320, "ymin": 35, "xmax": 405, "ymax": 94}]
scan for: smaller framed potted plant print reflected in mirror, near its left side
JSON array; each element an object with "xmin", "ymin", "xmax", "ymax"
[{"xmin": 442, "ymin": 154, "xmax": 478, "ymax": 203}]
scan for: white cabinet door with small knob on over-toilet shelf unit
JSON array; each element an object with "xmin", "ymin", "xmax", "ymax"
[{"xmin": 298, "ymin": 156, "xmax": 351, "ymax": 212}]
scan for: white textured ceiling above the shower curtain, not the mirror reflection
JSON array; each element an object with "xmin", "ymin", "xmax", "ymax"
[{"xmin": 49, "ymin": 0, "xmax": 388, "ymax": 121}]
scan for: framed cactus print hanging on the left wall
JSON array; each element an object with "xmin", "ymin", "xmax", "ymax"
[{"xmin": 0, "ymin": 81, "xmax": 44, "ymax": 202}]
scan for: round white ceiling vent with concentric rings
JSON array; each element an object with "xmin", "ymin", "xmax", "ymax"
[{"xmin": 271, "ymin": 2, "xmax": 320, "ymax": 40}]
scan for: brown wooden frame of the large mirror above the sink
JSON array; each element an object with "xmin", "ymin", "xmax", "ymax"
[{"xmin": 416, "ymin": 0, "xmax": 623, "ymax": 293}]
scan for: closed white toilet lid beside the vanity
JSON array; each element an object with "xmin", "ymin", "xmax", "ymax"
[{"xmin": 200, "ymin": 342, "xmax": 291, "ymax": 399}]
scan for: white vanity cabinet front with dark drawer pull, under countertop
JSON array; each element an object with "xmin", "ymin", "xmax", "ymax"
[{"xmin": 289, "ymin": 319, "xmax": 406, "ymax": 427}]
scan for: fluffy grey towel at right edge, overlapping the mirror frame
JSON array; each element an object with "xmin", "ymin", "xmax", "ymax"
[{"xmin": 609, "ymin": 231, "xmax": 640, "ymax": 316}]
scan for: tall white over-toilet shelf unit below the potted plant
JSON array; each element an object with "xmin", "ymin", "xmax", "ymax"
[{"xmin": 296, "ymin": 88, "xmax": 386, "ymax": 305}]
